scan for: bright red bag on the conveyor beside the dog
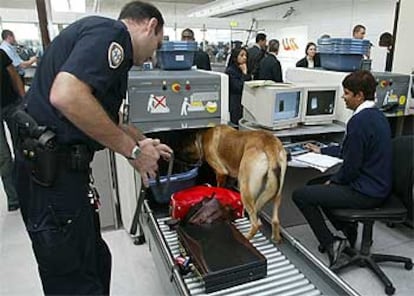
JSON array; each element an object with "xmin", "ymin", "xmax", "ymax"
[{"xmin": 170, "ymin": 185, "xmax": 244, "ymax": 220}]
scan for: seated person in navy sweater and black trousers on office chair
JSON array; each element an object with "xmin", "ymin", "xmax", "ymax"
[{"xmin": 293, "ymin": 71, "xmax": 392, "ymax": 266}]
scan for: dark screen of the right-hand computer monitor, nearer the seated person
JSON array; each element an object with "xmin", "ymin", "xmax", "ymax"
[{"xmin": 306, "ymin": 90, "xmax": 336, "ymax": 116}]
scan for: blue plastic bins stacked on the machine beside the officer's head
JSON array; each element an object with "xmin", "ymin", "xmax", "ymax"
[{"xmin": 157, "ymin": 41, "xmax": 197, "ymax": 70}]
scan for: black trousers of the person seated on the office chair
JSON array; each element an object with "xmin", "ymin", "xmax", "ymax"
[{"xmin": 293, "ymin": 176, "xmax": 383, "ymax": 247}]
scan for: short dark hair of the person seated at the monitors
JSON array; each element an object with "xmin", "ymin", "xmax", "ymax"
[{"xmin": 342, "ymin": 70, "xmax": 377, "ymax": 101}]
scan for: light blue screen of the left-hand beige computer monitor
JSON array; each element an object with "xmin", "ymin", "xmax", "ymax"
[{"xmin": 273, "ymin": 91, "xmax": 300, "ymax": 121}]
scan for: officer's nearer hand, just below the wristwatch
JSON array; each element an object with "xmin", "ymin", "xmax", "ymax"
[{"xmin": 130, "ymin": 138, "xmax": 160, "ymax": 187}]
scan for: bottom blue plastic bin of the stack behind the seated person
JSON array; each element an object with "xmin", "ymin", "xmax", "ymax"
[{"xmin": 320, "ymin": 53, "xmax": 364, "ymax": 72}]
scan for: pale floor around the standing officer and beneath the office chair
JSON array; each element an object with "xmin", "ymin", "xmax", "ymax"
[{"xmin": 0, "ymin": 179, "xmax": 414, "ymax": 296}]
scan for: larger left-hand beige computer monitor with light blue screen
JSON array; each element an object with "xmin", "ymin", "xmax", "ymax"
[{"xmin": 242, "ymin": 80, "xmax": 303, "ymax": 130}]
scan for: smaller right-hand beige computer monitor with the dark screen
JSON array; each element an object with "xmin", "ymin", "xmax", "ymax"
[{"xmin": 301, "ymin": 85, "xmax": 339, "ymax": 125}]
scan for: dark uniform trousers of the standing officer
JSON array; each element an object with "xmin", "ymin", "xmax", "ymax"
[{"xmin": 16, "ymin": 154, "xmax": 111, "ymax": 295}]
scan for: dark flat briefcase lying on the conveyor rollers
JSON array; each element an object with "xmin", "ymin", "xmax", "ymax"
[{"xmin": 177, "ymin": 220, "xmax": 267, "ymax": 293}]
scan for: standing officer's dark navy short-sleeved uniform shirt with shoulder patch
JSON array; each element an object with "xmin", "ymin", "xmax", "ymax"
[{"xmin": 26, "ymin": 16, "xmax": 133, "ymax": 150}]
